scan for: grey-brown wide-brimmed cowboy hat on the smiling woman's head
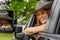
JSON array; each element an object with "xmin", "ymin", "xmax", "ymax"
[{"xmin": 30, "ymin": 1, "xmax": 52, "ymax": 14}]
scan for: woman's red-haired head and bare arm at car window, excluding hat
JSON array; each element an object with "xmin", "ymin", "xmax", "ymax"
[{"xmin": 24, "ymin": 9, "xmax": 50, "ymax": 40}]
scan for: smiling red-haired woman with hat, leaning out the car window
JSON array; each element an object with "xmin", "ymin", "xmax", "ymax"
[{"xmin": 24, "ymin": 1, "xmax": 50, "ymax": 40}]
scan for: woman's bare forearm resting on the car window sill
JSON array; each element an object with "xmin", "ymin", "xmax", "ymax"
[{"xmin": 24, "ymin": 24, "xmax": 46, "ymax": 35}]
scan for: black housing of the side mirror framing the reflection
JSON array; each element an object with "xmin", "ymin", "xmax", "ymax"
[{"xmin": 0, "ymin": 10, "xmax": 17, "ymax": 33}]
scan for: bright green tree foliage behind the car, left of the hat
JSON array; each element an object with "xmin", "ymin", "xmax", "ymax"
[{"xmin": 9, "ymin": 0, "xmax": 37, "ymax": 24}]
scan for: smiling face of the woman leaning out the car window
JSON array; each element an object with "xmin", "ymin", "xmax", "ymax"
[{"xmin": 37, "ymin": 10, "xmax": 48, "ymax": 24}]
